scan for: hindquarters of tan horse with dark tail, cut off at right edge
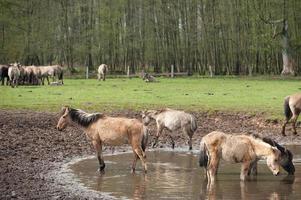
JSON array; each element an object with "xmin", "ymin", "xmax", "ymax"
[{"xmin": 281, "ymin": 93, "xmax": 301, "ymax": 136}]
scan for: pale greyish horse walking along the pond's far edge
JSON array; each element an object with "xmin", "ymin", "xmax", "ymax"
[{"xmin": 142, "ymin": 108, "xmax": 197, "ymax": 150}]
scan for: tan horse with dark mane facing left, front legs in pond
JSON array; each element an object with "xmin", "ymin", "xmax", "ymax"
[{"xmin": 56, "ymin": 106, "xmax": 148, "ymax": 173}]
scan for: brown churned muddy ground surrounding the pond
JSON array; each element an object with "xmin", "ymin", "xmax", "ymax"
[{"xmin": 0, "ymin": 110, "xmax": 301, "ymax": 199}]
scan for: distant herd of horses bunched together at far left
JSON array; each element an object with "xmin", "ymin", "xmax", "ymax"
[{"xmin": 0, "ymin": 63, "xmax": 64, "ymax": 87}]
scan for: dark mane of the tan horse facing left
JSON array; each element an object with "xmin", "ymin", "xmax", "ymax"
[{"xmin": 68, "ymin": 108, "xmax": 105, "ymax": 127}]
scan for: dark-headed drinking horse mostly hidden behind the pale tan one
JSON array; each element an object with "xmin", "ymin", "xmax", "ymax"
[{"xmin": 248, "ymin": 134, "xmax": 295, "ymax": 175}]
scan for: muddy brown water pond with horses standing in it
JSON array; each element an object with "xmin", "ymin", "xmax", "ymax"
[{"xmin": 69, "ymin": 146, "xmax": 301, "ymax": 199}]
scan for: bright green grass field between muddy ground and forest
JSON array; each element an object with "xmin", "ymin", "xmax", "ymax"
[{"xmin": 0, "ymin": 77, "xmax": 301, "ymax": 118}]
